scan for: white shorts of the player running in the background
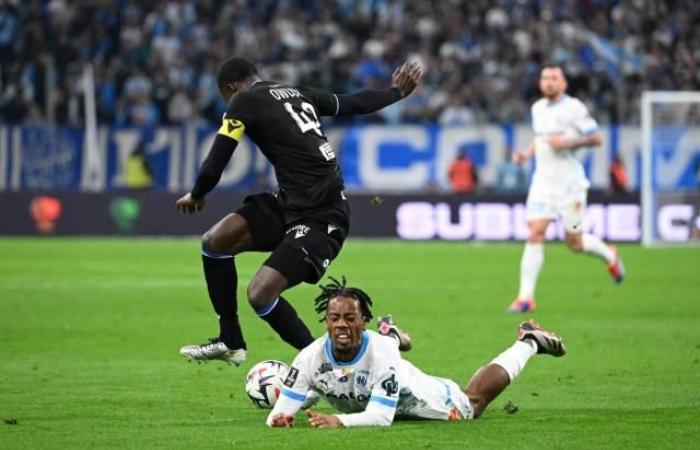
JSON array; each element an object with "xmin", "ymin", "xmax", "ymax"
[{"xmin": 525, "ymin": 183, "xmax": 587, "ymax": 233}]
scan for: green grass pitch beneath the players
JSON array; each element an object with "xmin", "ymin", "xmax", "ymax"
[{"xmin": 0, "ymin": 238, "xmax": 700, "ymax": 449}]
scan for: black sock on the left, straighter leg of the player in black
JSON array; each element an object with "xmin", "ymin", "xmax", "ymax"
[{"xmin": 202, "ymin": 255, "xmax": 246, "ymax": 349}]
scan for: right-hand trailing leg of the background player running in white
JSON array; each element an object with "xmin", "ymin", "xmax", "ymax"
[{"xmin": 560, "ymin": 190, "xmax": 624, "ymax": 283}]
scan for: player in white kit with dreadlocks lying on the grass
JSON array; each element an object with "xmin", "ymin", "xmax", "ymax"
[{"xmin": 267, "ymin": 279, "xmax": 566, "ymax": 428}]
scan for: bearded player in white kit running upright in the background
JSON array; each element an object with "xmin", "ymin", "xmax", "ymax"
[{"xmin": 508, "ymin": 65, "xmax": 624, "ymax": 313}]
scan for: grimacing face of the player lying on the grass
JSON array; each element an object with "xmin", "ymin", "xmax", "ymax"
[{"xmin": 326, "ymin": 297, "xmax": 365, "ymax": 352}]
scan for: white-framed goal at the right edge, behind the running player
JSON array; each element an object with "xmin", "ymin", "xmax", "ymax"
[{"xmin": 641, "ymin": 91, "xmax": 700, "ymax": 246}]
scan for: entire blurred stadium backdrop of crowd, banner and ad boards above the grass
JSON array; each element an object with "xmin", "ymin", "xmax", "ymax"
[{"xmin": 0, "ymin": 0, "xmax": 700, "ymax": 241}]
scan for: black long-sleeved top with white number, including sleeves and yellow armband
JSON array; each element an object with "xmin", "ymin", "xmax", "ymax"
[{"xmin": 191, "ymin": 81, "xmax": 401, "ymax": 228}]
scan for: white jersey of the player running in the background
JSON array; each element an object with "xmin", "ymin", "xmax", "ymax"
[{"xmin": 532, "ymin": 94, "xmax": 598, "ymax": 191}]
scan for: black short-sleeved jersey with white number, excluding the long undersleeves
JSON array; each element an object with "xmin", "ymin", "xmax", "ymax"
[{"xmin": 224, "ymin": 81, "xmax": 343, "ymax": 217}]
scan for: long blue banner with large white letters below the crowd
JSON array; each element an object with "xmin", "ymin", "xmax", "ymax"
[{"xmin": 0, "ymin": 125, "xmax": 700, "ymax": 192}]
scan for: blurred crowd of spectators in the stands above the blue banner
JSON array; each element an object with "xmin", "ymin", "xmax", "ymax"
[{"xmin": 0, "ymin": 0, "xmax": 700, "ymax": 125}]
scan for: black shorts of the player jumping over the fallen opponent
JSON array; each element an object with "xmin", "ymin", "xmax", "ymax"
[{"xmin": 236, "ymin": 194, "xmax": 348, "ymax": 287}]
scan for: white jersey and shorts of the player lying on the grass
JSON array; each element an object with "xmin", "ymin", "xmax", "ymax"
[{"xmin": 267, "ymin": 331, "xmax": 473, "ymax": 427}]
